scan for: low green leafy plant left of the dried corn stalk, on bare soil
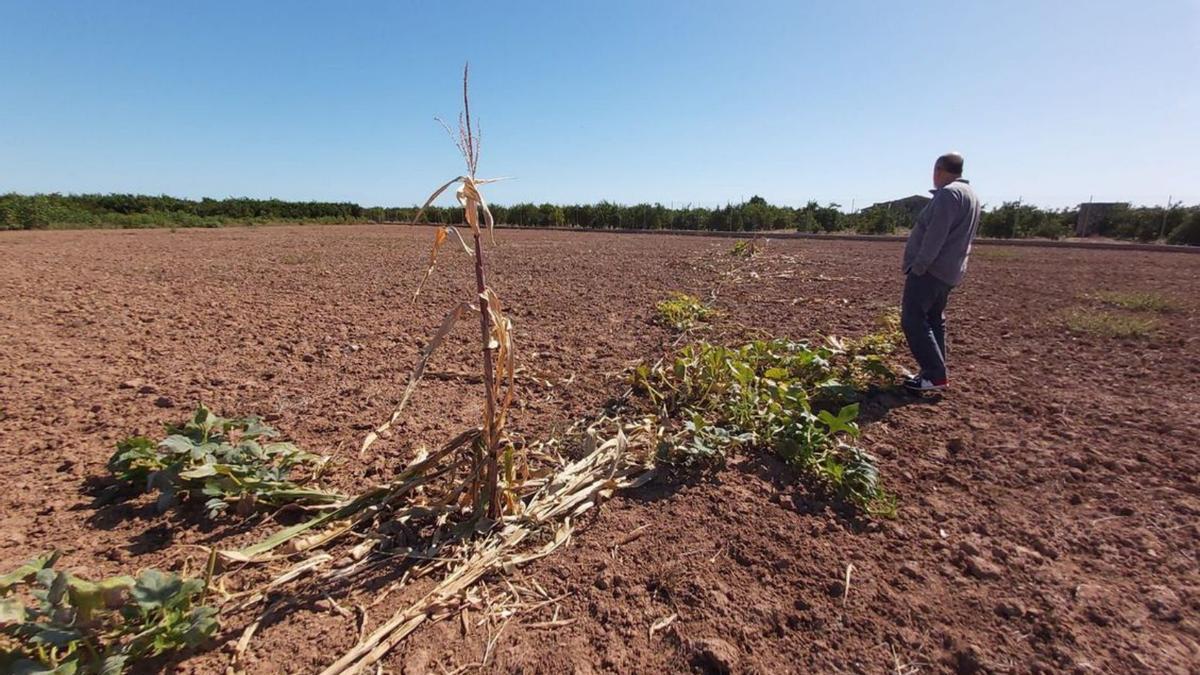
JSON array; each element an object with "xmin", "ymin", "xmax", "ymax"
[{"xmin": 108, "ymin": 405, "xmax": 344, "ymax": 518}]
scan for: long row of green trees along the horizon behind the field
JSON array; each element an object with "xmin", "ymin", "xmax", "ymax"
[{"xmin": 0, "ymin": 193, "xmax": 1200, "ymax": 245}]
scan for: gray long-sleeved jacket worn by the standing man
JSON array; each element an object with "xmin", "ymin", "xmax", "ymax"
[{"xmin": 904, "ymin": 178, "xmax": 979, "ymax": 286}]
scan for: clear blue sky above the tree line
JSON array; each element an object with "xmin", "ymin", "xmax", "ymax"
[{"xmin": 0, "ymin": 0, "xmax": 1200, "ymax": 208}]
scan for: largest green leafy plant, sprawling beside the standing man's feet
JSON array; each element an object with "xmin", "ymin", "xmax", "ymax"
[{"xmin": 634, "ymin": 317, "xmax": 899, "ymax": 515}]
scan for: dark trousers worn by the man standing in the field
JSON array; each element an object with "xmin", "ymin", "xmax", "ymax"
[{"xmin": 900, "ymin": 273, "xmax": 954, "ymax": 382}]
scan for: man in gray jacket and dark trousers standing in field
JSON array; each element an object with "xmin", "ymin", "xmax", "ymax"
[{"xmin": 900, "ymin": 153, "xmax": 979, "ymax": 392}]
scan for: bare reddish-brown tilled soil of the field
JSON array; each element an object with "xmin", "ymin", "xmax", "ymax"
[{"xmin": 0, "ymin": 226, "xmax": 1200, "ymax": 674}]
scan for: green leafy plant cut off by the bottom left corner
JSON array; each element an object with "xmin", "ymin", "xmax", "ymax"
[{"xmin": 0, "ymin": 551, "xmax": 217, "ymax": 675}]
